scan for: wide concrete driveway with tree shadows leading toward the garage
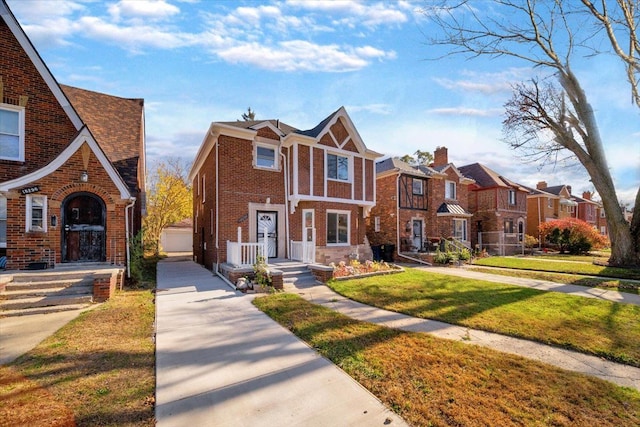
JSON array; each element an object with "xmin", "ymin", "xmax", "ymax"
[{"xmin": 156, "ymin": 258, "xmax": 406, "ymax": 427}]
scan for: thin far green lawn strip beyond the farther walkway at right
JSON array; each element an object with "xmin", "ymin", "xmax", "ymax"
[{"xmin": 473, "ymin": 257, "xmax": 640, "ymax": 280}]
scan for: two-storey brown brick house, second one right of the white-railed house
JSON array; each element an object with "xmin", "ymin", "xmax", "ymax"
[{"xmin": 459, "ymin": 163, "xmax": 529, "ymax": 255}]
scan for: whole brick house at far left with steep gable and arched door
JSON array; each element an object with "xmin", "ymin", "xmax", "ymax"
[{"xmin": 0, "ymin": 0, "xmax": 144, "ymax": 269}]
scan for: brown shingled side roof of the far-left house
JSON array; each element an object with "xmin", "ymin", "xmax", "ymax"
[{"xmin": 60, "ymin": 85, "xmax": 144, "ymax": 194}]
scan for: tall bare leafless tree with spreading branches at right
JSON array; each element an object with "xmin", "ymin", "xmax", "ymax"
[{"xmin": 424, "ymin": 0, "xmax": 640, "ymax": 265}]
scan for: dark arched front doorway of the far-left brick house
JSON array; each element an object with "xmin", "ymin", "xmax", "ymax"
[{"xmin": 62, "ymin": 193, "xmax": 106, "ymax": 262}]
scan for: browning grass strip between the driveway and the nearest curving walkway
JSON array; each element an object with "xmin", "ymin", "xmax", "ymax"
[{"xmin": 254, "ymin": 294, "xmax": 640, "ymax": 427}]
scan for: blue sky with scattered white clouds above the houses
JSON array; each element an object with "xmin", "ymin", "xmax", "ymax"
[{"xmin": 8, "ymin": 0, "xmax": 640, "ymax": 204}]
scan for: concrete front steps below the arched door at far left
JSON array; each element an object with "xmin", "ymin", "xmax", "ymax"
[{"xmin": 0, "ymin": 265, "xmax": 124, "ymax": 317}]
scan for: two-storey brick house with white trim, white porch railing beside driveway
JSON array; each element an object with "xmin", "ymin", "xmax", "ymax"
[{"xmin": 189, "ymin": 107, "xmax": 380, "ymax": 271}]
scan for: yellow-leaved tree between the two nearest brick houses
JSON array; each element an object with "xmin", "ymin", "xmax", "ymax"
[{"xmin": 142, "ymin": 158, "xmax": 193, "ymax": 255}]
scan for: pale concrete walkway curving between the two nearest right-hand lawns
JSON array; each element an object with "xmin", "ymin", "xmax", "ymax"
[{"xmin": 285, "ymin": 276, "xmax": 640, "ymax": 390}]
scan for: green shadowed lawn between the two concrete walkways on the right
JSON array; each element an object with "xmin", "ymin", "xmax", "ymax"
[{"xmin": 329, "ymin": 268, "xmax": 640, "ymax": 366}]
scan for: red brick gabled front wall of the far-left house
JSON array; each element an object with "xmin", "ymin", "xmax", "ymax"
[{"xmin": 0, "ymin": 4, "xmax": 144, "ymax": 270}]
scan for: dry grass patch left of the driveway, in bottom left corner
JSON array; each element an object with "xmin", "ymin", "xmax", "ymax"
[{"xmin": 0, "ymin": 289, "xmax": 155, "ymax": 426}]
